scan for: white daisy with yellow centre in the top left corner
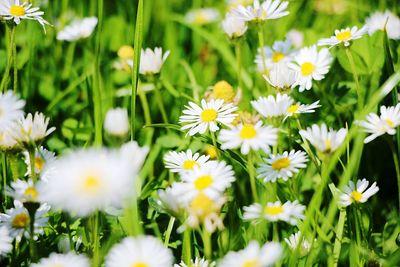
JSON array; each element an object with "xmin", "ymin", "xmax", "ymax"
[{"xmin": 0, "ymin": 0, "xmax": 50, "ymax": 31}]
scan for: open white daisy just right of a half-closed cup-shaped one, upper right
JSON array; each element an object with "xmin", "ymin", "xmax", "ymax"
[{"xmin": 289, "ymin": 45, "xmax": 333, "ymax": 92}]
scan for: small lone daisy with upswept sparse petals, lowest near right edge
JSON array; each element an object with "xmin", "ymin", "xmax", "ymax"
[{"xmin": 339, "ymin": 178, "xmax": 379, "ymax": 207}]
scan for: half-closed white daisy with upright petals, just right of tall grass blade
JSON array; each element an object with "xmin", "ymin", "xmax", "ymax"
[{"xmin": 138, "ymin": 47, "xmax": 170, "ymax": 75}]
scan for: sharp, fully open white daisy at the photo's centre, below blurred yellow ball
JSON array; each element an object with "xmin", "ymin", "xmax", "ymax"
[{"xmin": 179, "ymin": 99, "xmax": 237, "ymax": 136}]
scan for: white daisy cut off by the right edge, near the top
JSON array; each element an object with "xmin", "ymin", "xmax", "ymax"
[{"xmin": 365, "ymin": 10, "xmax": 400, "ymax": 40}]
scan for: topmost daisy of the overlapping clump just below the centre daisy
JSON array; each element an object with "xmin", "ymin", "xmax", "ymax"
[{"xmin": 164, "ymin": 149, "xmax": 210, "ymax": 173}]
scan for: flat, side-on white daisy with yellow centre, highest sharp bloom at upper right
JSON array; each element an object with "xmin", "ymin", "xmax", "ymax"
[{"xmin": 318, "ymin": 26, "xmax": 367, "ymax": 47}]
